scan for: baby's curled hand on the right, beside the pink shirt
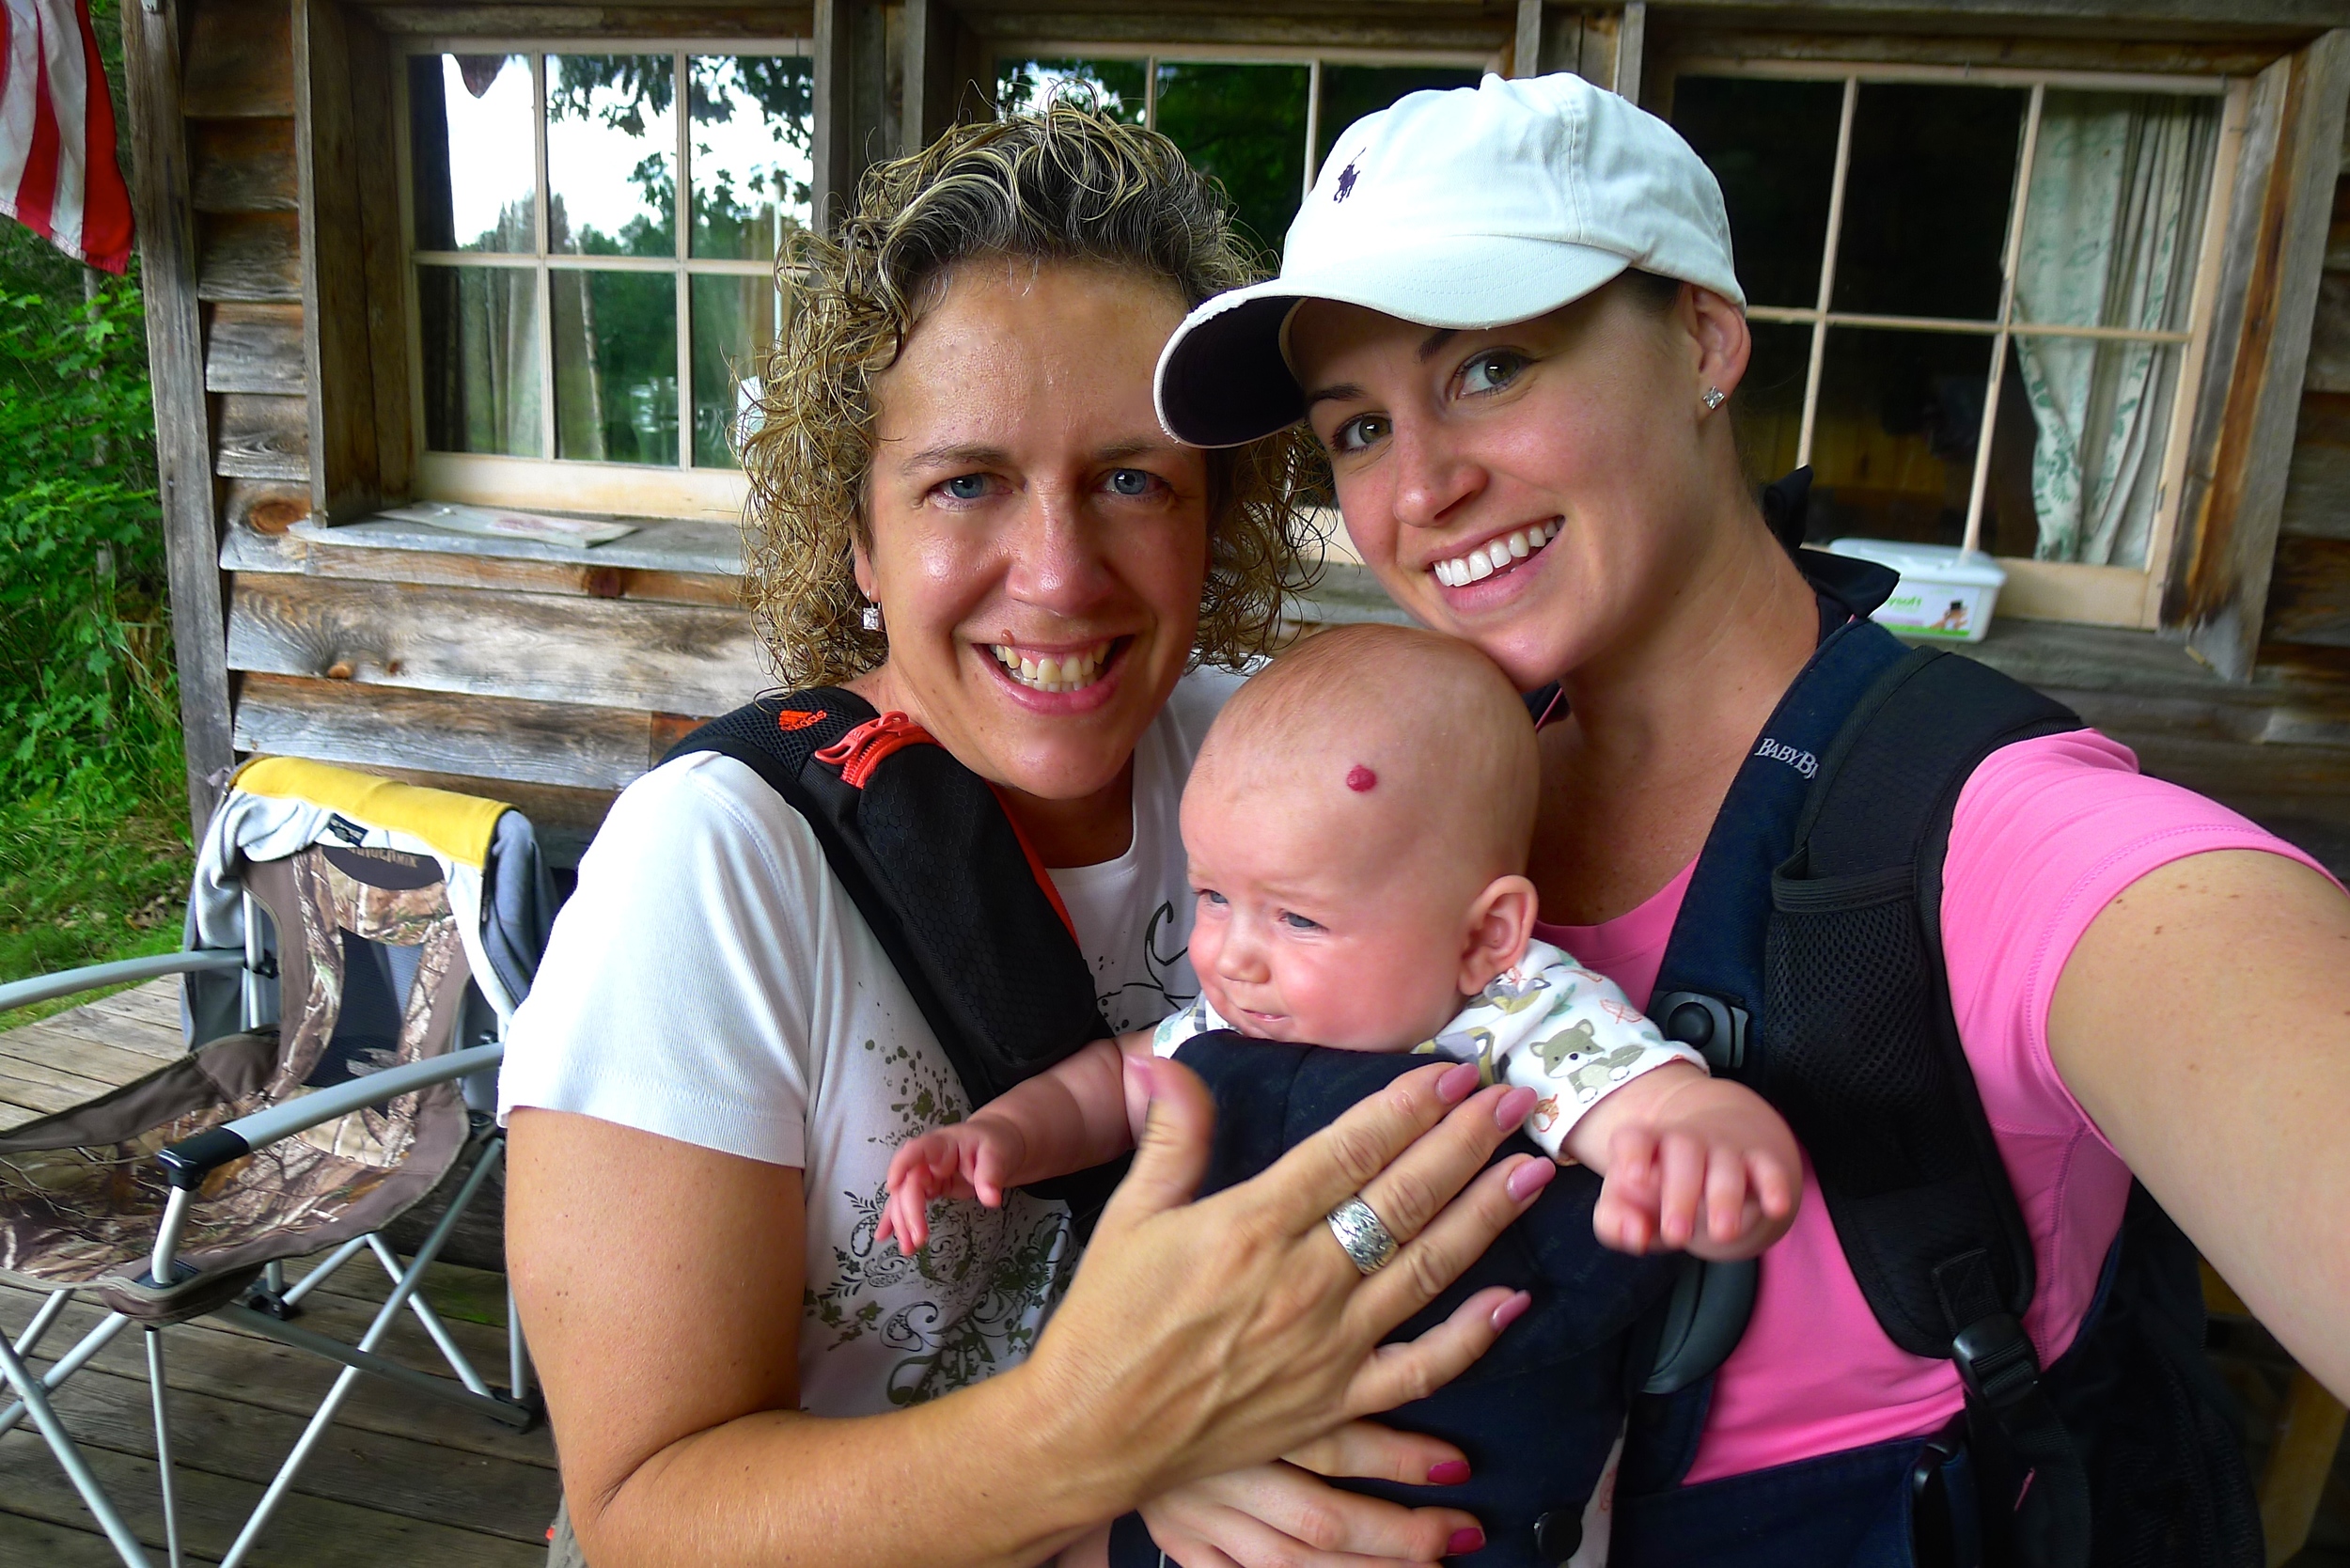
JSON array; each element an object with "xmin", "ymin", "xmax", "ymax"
[{"xmin": 1573, "ymin": 1062, "xmax": 1803, "ymax": 1262}]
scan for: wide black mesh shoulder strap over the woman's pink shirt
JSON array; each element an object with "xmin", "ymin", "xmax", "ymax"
[{"xmin": 1758, "ymin": 649, "xmax": 2090, "ymax": 1568}]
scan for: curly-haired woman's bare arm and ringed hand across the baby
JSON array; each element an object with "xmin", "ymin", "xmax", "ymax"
[{"xmin": 508, "ymin": 1065, "xmax": 1549, "ymax": 1568}]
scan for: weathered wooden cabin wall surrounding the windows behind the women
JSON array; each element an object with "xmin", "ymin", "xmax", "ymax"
[{"xmin": 127, "ymin": 0, "xmax": 2350, "ymax": 865}]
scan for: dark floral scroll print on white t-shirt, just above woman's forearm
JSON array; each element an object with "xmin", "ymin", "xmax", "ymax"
[{"xmin": 802, "ymin": 1039, "xmax": 1076, "ymax": 1405}]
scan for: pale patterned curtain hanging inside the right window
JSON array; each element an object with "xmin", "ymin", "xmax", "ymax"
[{"xmin": 2016, "ymin": 92, "xmax": 2218, "ymax": 567}]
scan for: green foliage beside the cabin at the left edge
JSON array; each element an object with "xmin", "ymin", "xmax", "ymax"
[{"xmin": 0, "ymin": 0, "xmax": 191, "ymax": 1006}]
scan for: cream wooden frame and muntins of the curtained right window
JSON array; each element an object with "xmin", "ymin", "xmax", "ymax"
[{"xmin": 1668, "ymin": 55, "xmax": 2254, "ymax": 630}]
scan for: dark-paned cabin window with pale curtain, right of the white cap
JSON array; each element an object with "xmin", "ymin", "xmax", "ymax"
[{"xmin": 1671, "ymin": 64, "xmax": 2226, "ymax": 583}]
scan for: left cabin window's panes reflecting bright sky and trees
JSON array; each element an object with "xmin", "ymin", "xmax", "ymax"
[{"xmin": 407, "ymin": 45, "xmax": 816, "ymax": 468}]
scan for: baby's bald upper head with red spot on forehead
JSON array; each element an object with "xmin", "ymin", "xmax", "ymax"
[{"xmin": 1187, "ymin": 625, "xmax": 1540, "ymax": 886}]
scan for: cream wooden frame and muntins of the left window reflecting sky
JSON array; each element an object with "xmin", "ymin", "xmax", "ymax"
[{"xmin": 393, "ymin": 36, "xmax": 816, "ymax": 522}]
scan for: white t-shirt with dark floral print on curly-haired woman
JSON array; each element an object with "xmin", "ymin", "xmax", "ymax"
[{"xmin": 498, "ymin": 670, "xmax": 1239, "ymax": 1415}]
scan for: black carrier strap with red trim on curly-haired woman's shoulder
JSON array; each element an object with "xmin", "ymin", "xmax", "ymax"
[{"xmin": 663, "ymin": 686, "xmax": 1123, "ymax": 1215}]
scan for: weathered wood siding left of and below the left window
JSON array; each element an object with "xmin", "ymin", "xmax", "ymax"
[{"xmin": 147, "ymin": 0, "xmax": 771, "ymax": 854}]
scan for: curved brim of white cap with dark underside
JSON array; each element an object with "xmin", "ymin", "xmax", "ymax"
[{"xmin": 1154, "ymin": 238, "xmax": 1631, "ymax": 447}]
